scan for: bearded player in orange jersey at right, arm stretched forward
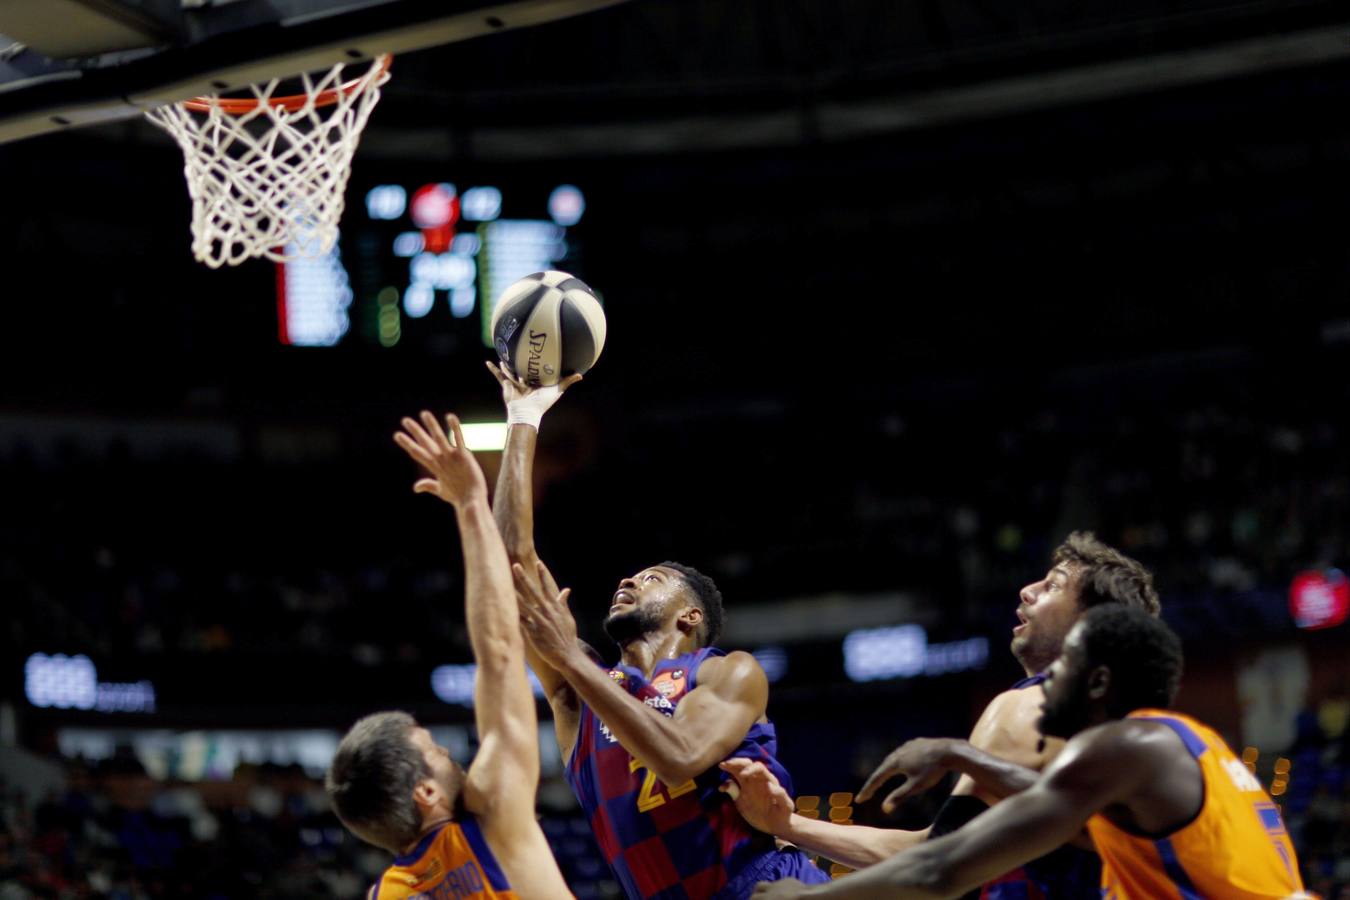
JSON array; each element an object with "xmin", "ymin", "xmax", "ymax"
[{"xmin": 755, "ymin": 607, "xmax": 1303, "ymax": 900}]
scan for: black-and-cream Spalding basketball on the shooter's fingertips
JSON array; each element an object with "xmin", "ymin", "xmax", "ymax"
[{"xmin": 493, "ymin": 271, "xmax": 605, "ymax": 387}]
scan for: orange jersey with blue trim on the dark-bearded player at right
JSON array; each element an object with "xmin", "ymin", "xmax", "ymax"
[{"xmin": 1088, "ymin": 710, "xmax": 1303, "ymax": 900}]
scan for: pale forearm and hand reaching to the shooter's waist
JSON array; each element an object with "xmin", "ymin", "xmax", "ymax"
[{"xmin": 721, "ymin": 757, "xmax": 927, "ymax": 869}]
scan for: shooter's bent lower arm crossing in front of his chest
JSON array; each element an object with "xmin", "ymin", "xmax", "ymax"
[{"xmin": 514, "ymin": 565, "xmax": 768, "ymax": 787}]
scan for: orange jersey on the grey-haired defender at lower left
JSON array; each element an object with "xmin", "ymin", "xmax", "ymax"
[{"xmin": 366, "ymin": 816, "xmax": 517, "ymax": 900}]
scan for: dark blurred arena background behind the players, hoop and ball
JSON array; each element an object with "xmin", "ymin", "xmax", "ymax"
[{"xmin": 0, "ymin": 0, "xmax": 1350, "ymax": 900}]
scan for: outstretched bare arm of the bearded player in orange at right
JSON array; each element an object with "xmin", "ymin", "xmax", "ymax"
[{"xmin": 755, "ymin": 723, "xmax": 1153, "ymax": 900}]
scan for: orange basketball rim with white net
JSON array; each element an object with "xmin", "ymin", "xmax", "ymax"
[{"xmin": 146, "ymin": 54, "xmax": 392, "ymax": 269}]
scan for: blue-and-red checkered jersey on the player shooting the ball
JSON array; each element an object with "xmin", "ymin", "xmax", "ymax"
[{"xmin": 567, "ymin": 648, "xmax": 829, "ymax": 900}]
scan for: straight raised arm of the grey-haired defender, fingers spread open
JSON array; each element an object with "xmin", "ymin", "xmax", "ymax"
[{"xmin": 394, "ymin": 412, "xmax": 539, "ymax": 824}]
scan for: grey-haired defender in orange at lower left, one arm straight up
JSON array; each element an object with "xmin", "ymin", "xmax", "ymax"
[{"xmin": 327, "ymin": 412, "xmax": 571, "ymax": 900}]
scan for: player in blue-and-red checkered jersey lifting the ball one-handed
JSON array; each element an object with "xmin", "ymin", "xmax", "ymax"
[{"xmin": 489, "ymin": 366, "xmax": 829, "ymax": 900}]
